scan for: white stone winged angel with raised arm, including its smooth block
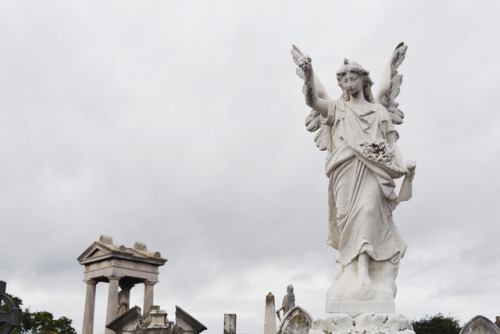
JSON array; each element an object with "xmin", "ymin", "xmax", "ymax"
[{"xmin": 292, "ymin": 43, "xmax": 416, "ymax": 313}]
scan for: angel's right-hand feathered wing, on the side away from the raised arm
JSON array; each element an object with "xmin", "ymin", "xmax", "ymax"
[{"xmin": 376, "ymin": 42, "xmax": 408, "ymax": 124}]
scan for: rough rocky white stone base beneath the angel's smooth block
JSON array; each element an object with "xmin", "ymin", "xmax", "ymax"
[{"xmin": 309, "ymin": 313, "xmax": 415, "ymax": 334}]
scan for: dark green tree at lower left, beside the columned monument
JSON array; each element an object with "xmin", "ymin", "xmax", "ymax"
[{"xmin": 2, "ymin": 294, "xmax": 76, "ymax": 334}]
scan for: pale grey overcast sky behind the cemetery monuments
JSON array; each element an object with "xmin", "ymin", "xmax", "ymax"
[{"xmin": 0, "ymin": 0, "xmax": 500, "ymax": 334}]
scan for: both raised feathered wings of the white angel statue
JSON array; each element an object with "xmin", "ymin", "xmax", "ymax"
[{"xmin": 292, "ymin": 42, "xmax": 408, "ymax": 150}]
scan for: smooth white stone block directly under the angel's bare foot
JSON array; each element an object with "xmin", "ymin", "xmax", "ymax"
[{"xmin": 325, "ymin": 261, "xmax": 399, "ymax": 315}]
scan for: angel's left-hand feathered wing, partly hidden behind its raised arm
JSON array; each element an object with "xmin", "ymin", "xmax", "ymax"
[{"xmin": 292, "ymin": 45, "xmax": 331, "ymax": 151}]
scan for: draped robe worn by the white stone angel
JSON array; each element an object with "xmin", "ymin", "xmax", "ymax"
[{"xmin": 323, "ymin": 100, "xmax": 406, "ymax": 266}]
